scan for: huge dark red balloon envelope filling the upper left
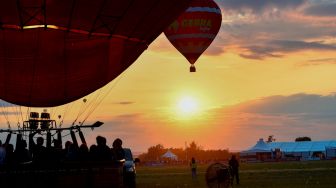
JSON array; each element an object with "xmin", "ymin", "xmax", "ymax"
[{"xmin": 0, "ymin": 0, "xmax": 190, "ymax": 107}]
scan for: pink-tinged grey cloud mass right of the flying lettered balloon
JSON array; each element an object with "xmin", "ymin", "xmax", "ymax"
[{"xmin": 217, "ymin": 0, "xmax": 336, "ymax": 60}]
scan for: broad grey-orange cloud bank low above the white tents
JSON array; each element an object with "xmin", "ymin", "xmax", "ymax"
[{"xmin": 205, "ymin": 93, "xmax": 336, "ymax": 144}]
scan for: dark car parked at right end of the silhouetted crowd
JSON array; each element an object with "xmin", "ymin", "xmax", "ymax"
[{"xmin": 123, "ymin": 148, "xmax": 140, "ymax": 188}]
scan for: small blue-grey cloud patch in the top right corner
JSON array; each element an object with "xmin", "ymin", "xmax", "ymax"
[{"xmin": 304, "ymin": 1, "xmax": 336, "ymax": 16}]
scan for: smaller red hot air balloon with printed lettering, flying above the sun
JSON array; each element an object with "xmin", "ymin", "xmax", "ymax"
[{"xmin": 164, "ymin": 0, "xmax": 222, "ymax": 72}]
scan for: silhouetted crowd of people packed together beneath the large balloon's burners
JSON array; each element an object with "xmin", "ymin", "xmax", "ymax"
[{"xmin": 0, "ymin": 134, "xmax": 125, "ymax": 165}]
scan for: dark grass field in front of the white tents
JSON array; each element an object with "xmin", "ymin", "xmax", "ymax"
[{"xmin": 137, "ymin": 161, "xmax": 336, "ymax": 188}]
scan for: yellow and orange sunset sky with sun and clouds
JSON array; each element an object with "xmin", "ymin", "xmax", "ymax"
[{"xmin": 0, "ymin": 0, "xmax": 336, "ymax": 151}]
